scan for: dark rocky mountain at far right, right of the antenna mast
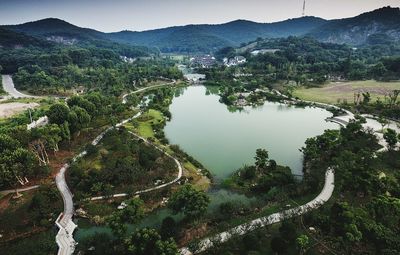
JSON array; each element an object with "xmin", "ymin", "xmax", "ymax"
[{"xmin": 309, "ymin": 7, "xmax": 400, "ymax": 45}]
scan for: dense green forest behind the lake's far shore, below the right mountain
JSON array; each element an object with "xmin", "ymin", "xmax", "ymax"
[{"xmin": 211, "ymin": 37, "xmax": 400, "ymax": 86}]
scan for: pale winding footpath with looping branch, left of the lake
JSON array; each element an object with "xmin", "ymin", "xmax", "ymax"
[{"xmin": 56, "ymin": 80, "xmax": 177, "ymax": 255}]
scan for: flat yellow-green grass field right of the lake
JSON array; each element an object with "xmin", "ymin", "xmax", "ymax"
[{"xmin": 293, "ymin": 80, "xmax": 400, "ymax": 104}]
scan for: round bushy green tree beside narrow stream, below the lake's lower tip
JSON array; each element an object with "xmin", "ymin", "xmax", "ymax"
[{"xmin": 168, "ymin": 185, "xmax": 210, "ymax": 218}]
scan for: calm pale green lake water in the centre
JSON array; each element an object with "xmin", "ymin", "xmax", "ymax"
[{"xmin": 164, "ymin": 86, "xmax": 338, "ymax": 180}]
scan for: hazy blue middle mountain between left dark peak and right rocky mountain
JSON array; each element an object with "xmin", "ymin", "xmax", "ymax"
[{"xmin": 106, "ymin": 17, "xmax": 326, "ymax": 52}]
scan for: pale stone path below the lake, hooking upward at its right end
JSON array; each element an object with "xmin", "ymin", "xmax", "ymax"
[{"xmin": 180, "ymin": 168, "xmax": 335, "ymax": 255}]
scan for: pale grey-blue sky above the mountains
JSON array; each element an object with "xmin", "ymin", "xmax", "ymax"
[{"xmin": 0, "ymin": 0, "xmax": 400, "ymax": 32}]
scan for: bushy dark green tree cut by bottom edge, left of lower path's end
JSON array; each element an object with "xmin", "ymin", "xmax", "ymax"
[{"xmin": 124, "ymin": 228, "xmax": 179, "ymax": 255}]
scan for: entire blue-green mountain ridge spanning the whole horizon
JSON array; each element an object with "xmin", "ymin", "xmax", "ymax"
[{"xmin": 3, "ymin": 7, "xmax": 400, "ymax": 53}]
